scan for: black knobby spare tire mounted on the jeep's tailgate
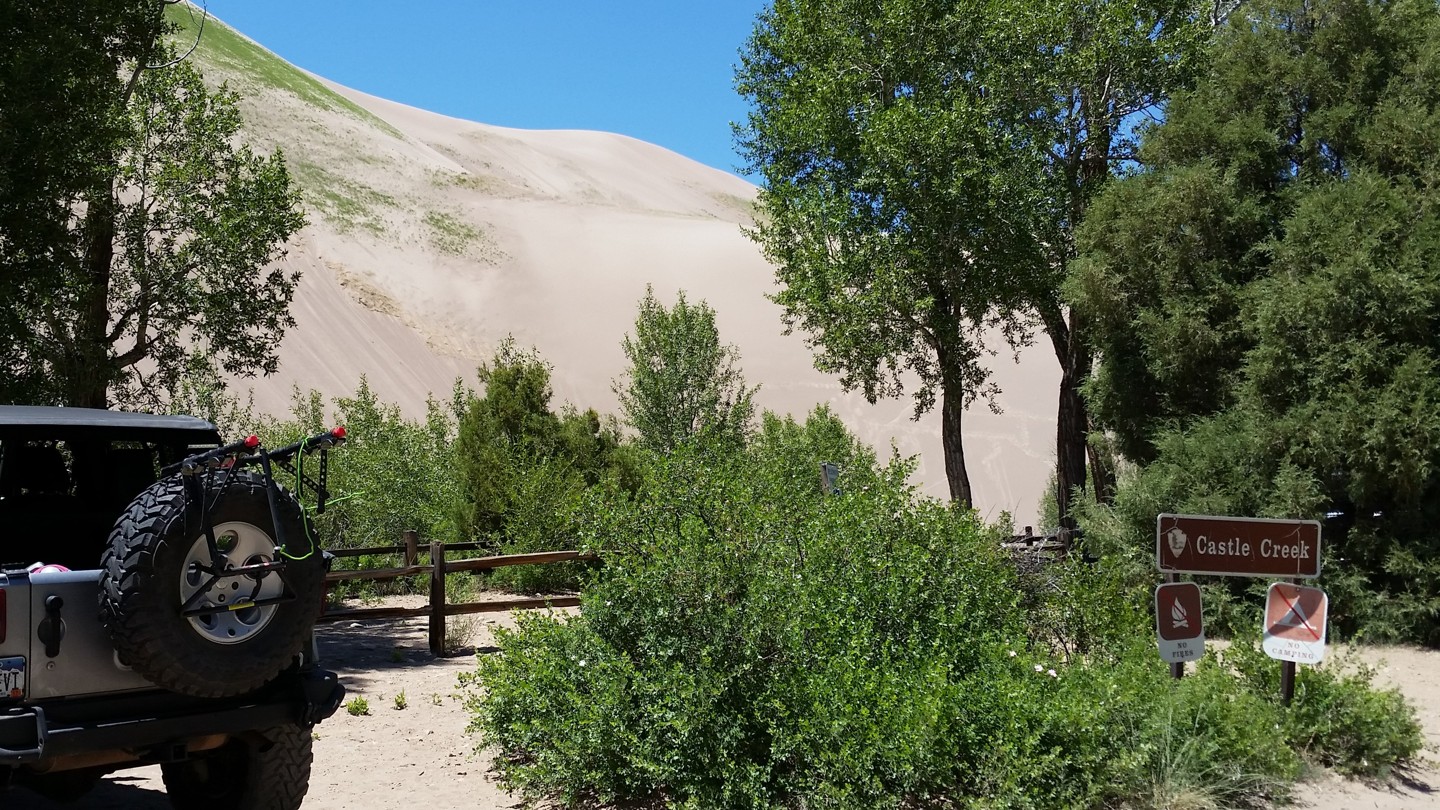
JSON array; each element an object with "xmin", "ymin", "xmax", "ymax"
[{"xmin": 99, "ymin": 470, "xmax": 324, "ymax": 698}]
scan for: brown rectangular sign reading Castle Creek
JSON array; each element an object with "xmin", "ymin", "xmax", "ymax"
[{"xmin": 1155, "ymin": 515, "xmax": 1320, "ymax": 579}]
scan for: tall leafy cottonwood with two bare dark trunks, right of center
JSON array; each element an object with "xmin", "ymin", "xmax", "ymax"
[{"xmin": 737, "ymin": 0, "xmax": 1208, "ymax": 515}]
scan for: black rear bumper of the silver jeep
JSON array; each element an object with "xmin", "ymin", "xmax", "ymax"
[{"xmin": 0, "ymin": 669, "xmax": 346, "ymax": 767}]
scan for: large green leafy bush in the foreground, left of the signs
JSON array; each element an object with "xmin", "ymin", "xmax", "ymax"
[{"xmin": 464, "ymin": 423, "xmax": 1414, "ymax": 809}]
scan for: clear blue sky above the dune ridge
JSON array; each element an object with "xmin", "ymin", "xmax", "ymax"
[{"xmin": 196, "ymin": 0, "xmax": 766, "ymax": 172}]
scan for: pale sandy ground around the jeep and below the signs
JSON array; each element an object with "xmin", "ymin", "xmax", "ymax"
[{"xmin": 0, "ymin": 597, "xmax": 1440, "ymax": 810}]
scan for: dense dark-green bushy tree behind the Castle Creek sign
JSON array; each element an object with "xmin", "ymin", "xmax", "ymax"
[{"xmin": 1070, "ymin": 0, "xmax": 1440, "ymax": 644}]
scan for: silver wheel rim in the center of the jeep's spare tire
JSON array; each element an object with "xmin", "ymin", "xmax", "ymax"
[{"xmin": 180, "ymin": 522, "xmax": 285, "ymax": 644}]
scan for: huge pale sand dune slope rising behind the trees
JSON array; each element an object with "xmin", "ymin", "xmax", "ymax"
[{"xmin": 188, "ymin": 18, "xmax": 1058, "ymax": 523}]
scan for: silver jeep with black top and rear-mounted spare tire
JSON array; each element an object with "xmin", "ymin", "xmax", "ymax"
[{"xmin": 0, "ymin": 406, "xmax": 344, "ymax": 810}]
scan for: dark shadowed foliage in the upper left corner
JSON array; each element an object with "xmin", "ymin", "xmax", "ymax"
[{"xmin": 0, "ymin": 0, "xmax": 164, "ymax": 402}]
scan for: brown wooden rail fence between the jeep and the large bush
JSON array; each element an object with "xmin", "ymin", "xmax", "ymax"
[{"xmin": 320, "ymin": 532, "xmax": 596, "ymax": 657}]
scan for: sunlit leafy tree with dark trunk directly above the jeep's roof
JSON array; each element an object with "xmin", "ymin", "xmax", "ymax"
[{"xmin": 0, "ymin": 0, "xmax": 304, "ymax": 408}]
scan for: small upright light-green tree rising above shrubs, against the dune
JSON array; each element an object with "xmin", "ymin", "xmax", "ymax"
[{"xmin": 615, "ymin": 287, "xmax": 756, "ymax": 453}]
